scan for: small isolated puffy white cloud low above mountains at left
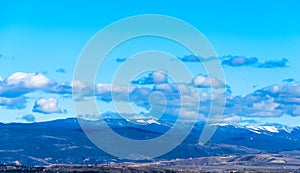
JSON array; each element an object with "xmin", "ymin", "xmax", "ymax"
[{"xmin": 32, "ymin": 98, "xmax": 63, "ymax": 114}]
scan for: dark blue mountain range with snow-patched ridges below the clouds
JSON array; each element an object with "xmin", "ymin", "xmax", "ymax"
[{"xmin": 0, "ymin": 118, "xmax": 300, "ymax": 166}]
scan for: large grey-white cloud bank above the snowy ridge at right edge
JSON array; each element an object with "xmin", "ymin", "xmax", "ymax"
[{"xmin": 225, "ymin": 83, "xmax": 300, "ymax": 117}]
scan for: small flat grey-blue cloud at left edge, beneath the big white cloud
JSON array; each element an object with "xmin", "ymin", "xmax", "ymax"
[{"xmin": 0, "ymin": 97, "xmax": 26, "ymax": 109}]
